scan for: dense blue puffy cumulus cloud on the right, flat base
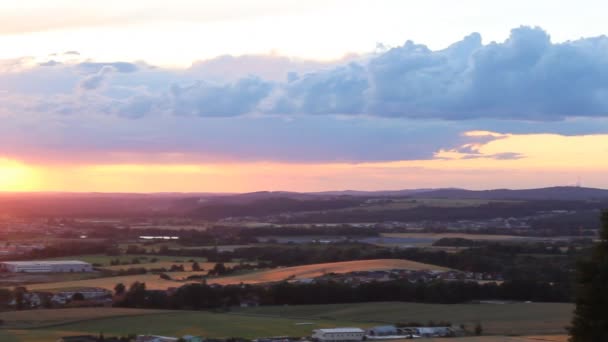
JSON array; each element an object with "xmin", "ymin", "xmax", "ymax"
[{"xmin": 278, "ymin": 27, "xmax": 608, "ymax": 121}]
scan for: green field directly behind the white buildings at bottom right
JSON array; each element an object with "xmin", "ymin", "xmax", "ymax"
[{"xmin": 235, "ymin": 302, "xmax": 574, "ymax": 335}]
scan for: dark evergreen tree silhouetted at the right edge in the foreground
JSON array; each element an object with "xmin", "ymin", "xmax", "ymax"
[{"xmin": 568, "ymin": 210, "xmax": 608, "ymax": 342}]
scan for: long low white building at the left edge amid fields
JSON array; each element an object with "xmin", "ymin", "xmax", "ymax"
[{"xmin": 0, "ymin": 260, "xmax": 93, "ymax": 273}]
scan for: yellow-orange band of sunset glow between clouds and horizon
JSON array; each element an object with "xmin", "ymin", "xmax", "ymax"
[{"xmin": 0, "ymin": 132, "xmax": 608, "ymax": 193}]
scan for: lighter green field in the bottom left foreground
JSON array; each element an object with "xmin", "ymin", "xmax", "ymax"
[{"xmin": 0, "ymin": 308, "xmax": 360, "ymax": 342}]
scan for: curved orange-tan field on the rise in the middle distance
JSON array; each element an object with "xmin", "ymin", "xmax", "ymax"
[{"xmin": 208, "ymin": 259, "xmax": 448, "ymax": 285}]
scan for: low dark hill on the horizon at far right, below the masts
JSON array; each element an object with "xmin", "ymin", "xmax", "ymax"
[{"xmin": 411, "ymin": 186, "xmax": 608, "ymax": 201}]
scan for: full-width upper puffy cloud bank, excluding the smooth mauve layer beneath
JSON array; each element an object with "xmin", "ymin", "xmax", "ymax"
[{"xmin": 0, "ymin": 27, "xmax": 608, "ymax": 122}]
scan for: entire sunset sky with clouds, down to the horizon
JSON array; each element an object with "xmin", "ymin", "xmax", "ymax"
[{"xmin": 0, "ymin": 0, "xmax": 608, "ymax": 192}]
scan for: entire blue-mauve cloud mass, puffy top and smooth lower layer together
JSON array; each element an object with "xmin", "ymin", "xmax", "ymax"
[{"xmin": 0, "ymin": 27, "xmax": 608, "ymax": 163}]
